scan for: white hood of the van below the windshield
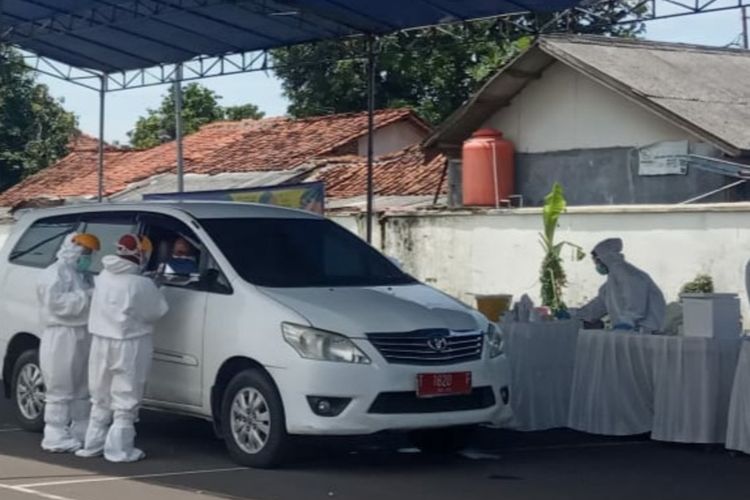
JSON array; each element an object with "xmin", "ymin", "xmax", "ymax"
[{"xmin": 262, "ymin": 285, "xmax": 483, "ymax": 338}]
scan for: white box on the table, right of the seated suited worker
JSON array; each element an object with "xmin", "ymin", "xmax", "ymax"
[{"xmin": 680, "ymin": 293, "xmax": 742, "ymax": 338}]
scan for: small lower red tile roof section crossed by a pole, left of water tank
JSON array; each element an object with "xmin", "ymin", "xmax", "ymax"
[{"xmin": 306, "ymin": 145, "xmax": 446, "ymax": 198}]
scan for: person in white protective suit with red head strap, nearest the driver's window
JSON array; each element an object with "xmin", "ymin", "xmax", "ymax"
[{"xmin": 76, "ymin": 234, "xmax": 168, "ymax": 462}]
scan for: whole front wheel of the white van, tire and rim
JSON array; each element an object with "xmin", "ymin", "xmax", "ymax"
[{"xmin": 221, "ymin": 370, "xmax": 290, "ymax": 469}]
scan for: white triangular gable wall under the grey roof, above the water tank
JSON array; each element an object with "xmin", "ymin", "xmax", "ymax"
[{"xmin": 484, "ymin": 62, "xmax": 697, "ymax": 153}]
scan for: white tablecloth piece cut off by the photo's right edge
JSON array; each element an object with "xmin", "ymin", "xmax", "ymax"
[{"xmin": 726, "ymin": 339, "xmax": 750, "ymax": 453}]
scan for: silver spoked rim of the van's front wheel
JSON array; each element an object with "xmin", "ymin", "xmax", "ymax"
[{"xmin": 234, "ymin": 387, "xmax": 271, "ymax": 455}]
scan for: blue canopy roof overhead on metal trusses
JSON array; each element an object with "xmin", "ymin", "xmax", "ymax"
[{"xmin": 0, "ymin": 0, "xmax": 578, "ymax": 73}]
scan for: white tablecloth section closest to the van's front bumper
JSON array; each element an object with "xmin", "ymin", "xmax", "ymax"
[{"xmin": 505, "ymin": 321, "xmax": 580, "ymax": 431}]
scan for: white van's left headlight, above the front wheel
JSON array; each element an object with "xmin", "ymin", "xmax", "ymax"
[{"xmin": 281, "ymin": 323, "xmax": 370, "ymax": 364}]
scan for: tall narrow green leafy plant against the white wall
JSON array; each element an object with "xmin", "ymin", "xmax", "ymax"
[{"xmin": 539, "ymin": 182, "xmax": 586, "ymax": 313}]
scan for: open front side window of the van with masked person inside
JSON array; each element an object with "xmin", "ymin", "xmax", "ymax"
[{"xmin": 139, "ymin": 214, "xmax": 231, "ymax": 293}]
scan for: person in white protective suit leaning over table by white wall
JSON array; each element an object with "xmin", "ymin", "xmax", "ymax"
[{"xmin": 576, "ymin": 238, "xmax": 666, "ymax": 333}]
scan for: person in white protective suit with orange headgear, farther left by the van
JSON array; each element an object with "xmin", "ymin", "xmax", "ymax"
[{"xmin": 37, "ymin": 233, "xmax": 99, "ymax": 453}]
